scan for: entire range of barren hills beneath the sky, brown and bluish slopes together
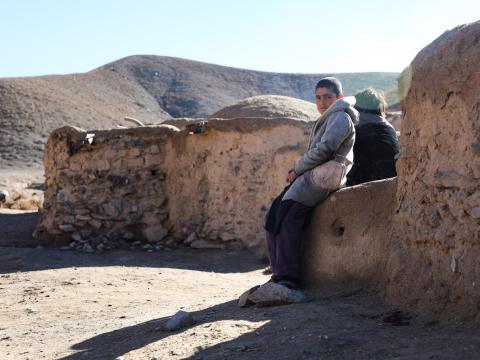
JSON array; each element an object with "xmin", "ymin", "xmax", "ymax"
[{"xmin": 0, "ymin": 56, "xmax": 398, "ymax": 169}]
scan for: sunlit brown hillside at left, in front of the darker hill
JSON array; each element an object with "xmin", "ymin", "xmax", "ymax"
[{"xmin": 0, "ymin": 70, "xmax": 171, "ymax": 169}]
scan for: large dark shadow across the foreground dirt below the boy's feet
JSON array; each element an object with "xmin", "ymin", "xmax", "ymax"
[{"xmin": 57, "ymin": 294, "xmax": 480, "ymax": 360}]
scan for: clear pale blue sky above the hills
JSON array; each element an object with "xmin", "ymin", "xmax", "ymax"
[{"xmin": 0, "ymin": 0, "xmax": 480, "ymax": 77}]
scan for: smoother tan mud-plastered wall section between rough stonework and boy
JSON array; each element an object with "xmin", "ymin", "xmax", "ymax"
[{"xmin": 166, "ymin": 119, "xmax": 307, "ymax": 252}]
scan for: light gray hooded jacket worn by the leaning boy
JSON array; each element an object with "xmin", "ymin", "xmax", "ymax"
[{"xmin": 282, "ymin": 96, "xmax": 358, "ymax": 207}]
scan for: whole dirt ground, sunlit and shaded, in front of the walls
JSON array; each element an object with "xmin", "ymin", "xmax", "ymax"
[{"xmin": 0, "ymin": 174, "xmax": 480, "ymax": 360}]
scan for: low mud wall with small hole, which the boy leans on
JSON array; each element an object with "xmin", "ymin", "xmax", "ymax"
[{"xmin": 303, "ymin": 178, "xmax": 396, "ymax": 285}]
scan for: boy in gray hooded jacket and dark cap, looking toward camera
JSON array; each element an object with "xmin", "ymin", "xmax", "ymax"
[{"xmin": 265, "ymin": 77, "xmax": 358, "ymax": 289}]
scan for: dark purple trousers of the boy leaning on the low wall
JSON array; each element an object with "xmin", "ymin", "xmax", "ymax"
[{"xmin": 267, "ymin": 200, "xmax": 313, "ymax": 279}]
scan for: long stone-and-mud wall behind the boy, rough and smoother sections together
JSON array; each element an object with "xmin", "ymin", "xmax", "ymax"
[{"xmin": 35, "ymin": 119, "xmax": 308, "ymax": 253}]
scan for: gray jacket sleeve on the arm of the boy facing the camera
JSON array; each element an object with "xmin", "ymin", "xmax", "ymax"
[{"xmin": 293, "ymin": 111, "xmax": 353, "ymax": 175}]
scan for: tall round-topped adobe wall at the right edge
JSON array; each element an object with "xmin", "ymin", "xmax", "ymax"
[{"xmin": 386, "ymin": 22, "xmax": 480, "ymax": 317}]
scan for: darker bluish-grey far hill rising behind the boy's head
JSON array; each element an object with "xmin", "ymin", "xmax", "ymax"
[{"xmin": 102, "ymin": 56, "xmax": 398, "ymax": 117}]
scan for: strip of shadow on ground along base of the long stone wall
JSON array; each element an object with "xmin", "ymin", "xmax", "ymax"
[{"xmin": 0, "ymin": 212, "xmax": 266, "ymax": 274}]
